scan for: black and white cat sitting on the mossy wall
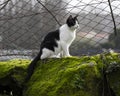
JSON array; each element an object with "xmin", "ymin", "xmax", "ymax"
[{"xmin": 26, "ymin": 15, "xmax": 79, "ymax": 80}]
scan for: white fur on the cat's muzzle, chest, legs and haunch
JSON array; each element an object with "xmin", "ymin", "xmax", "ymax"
[{"xmin": 40, "ymin": 21, "xmax": 79, "ymax": 59}]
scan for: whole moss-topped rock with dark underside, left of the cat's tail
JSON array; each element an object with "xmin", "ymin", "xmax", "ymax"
[{"xmin": 0, "ymin": 59, "xmax": 30, "ymax": 96}]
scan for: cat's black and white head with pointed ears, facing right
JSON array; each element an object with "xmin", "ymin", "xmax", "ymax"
[{"xmin": 66, "ymin": 15, "xmax": 79, "ymax": 29}]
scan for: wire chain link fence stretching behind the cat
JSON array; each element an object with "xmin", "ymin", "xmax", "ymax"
[{"xmin": 0, "ymin": 0, "xmax": 120, "ymax": 60}]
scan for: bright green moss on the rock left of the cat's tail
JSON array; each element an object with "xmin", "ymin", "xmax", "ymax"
[{"xmin": 0, "ymin": 59, "xmax": 30, "ymax": 80}]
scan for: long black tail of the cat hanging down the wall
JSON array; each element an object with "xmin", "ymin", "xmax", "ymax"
[{"xmin": 25, "ymin": 51, "xmax": 41, "ymax": 82}]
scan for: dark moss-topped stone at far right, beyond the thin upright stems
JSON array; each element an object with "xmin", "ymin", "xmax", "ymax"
[{"xmin": 102, "ymin": 54, "xmax": 120, "ymax": 96}]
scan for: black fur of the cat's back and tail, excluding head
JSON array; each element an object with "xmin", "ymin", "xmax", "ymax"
[{"xmin": 25, "ymin": 30, "xmax": 60, "ymax": 81}]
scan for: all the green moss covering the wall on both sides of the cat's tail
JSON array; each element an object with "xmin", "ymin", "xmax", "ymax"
[{"xmin": 0, "ymin": 53, "xmax": 120, "ymax": 96}]
